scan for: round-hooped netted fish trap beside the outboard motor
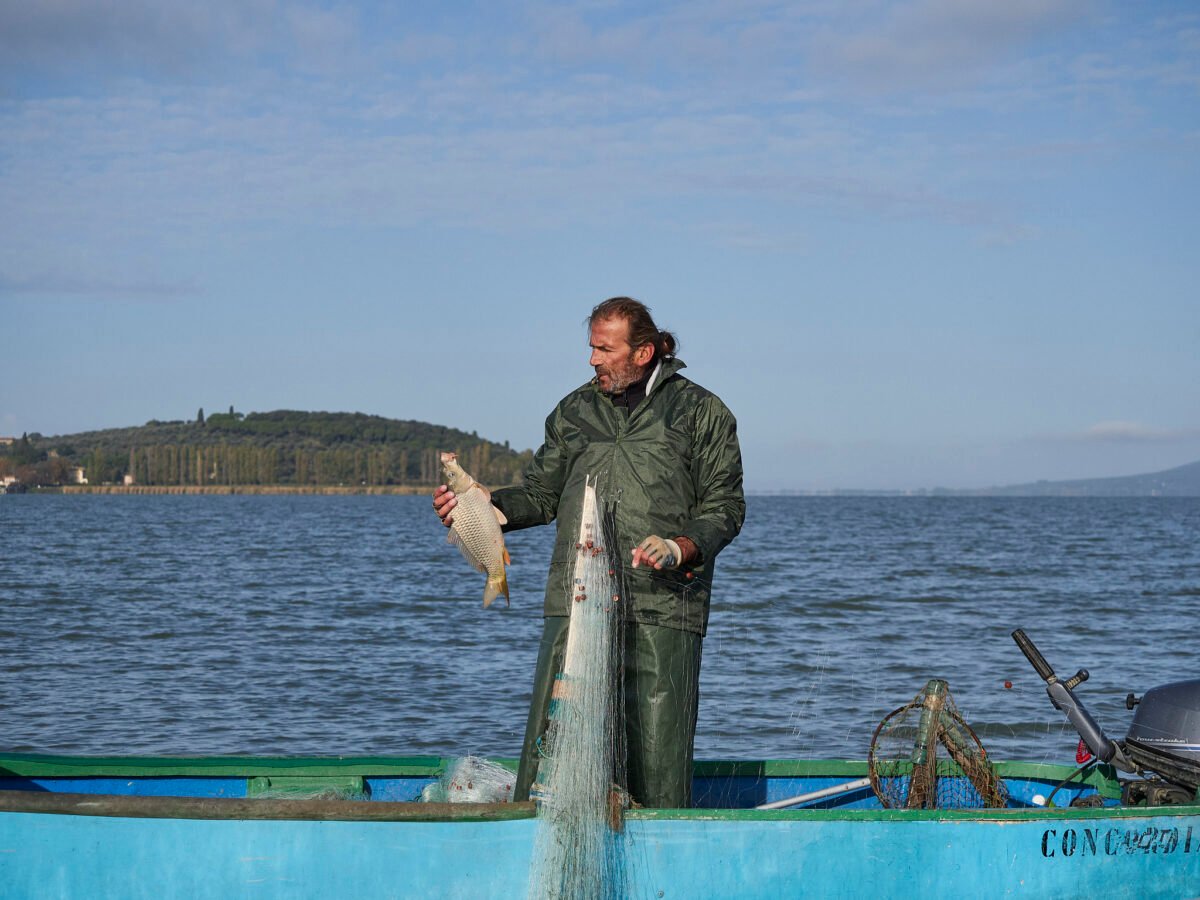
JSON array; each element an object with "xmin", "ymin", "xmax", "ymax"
[{"xmin": 866, "ymin": 678, "xmax": 1008, "ymax": 809}]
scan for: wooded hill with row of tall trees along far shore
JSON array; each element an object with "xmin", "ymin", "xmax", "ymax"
[{"xmin": 0, "ymin": 408, "xmax": 533, "ymax": 486}]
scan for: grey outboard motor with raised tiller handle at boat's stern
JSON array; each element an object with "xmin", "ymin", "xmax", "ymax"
[{"xmin": 1013, "ymin": 629, "xmax": 1200, "ymax": 805}]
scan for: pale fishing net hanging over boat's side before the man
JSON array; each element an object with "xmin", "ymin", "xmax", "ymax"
[{"xmin": 529, "ymin": 475, "xmax": 626, "ymax": 898}]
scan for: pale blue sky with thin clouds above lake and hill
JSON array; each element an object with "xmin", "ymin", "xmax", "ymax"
[{"xmin": 0, "ymin": 0, "xmax": 1200, "ymax": 492}]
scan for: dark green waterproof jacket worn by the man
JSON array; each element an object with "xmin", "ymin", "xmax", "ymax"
[{"xmin": 492, "ymin": 359, "xmax": 745, "ymax": 635}]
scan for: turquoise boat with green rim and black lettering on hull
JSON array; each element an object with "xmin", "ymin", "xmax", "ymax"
[{"xmin": 0, "ymin": 754, "xmax": 1200, "ymax": 898}]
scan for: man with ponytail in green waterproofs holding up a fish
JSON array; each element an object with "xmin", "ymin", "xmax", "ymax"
[{"xmin": 433, "ymin": 296, "xmax": 745, "ymax": 808}]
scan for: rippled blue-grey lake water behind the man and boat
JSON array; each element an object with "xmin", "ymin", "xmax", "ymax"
[{"xmin": 0, "ymin": 496, "xmax": 1200, "ymax": 762}]
